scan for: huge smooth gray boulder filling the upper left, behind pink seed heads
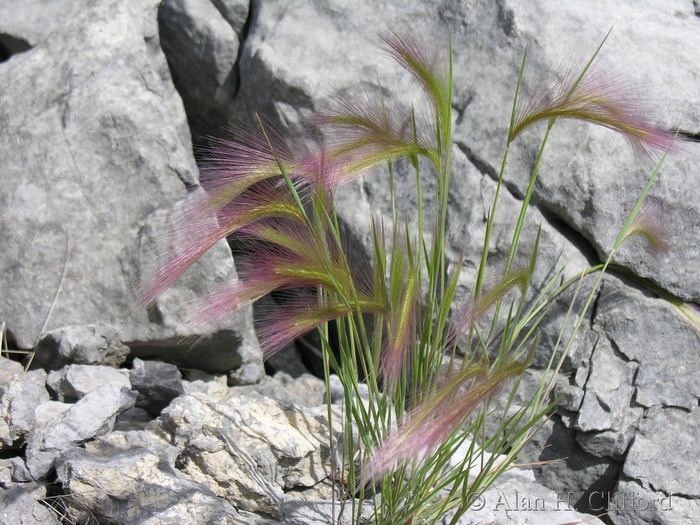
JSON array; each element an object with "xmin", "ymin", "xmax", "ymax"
[{"xmin": 0, "ymin": 0, "xmax": 262, "ymax": 380}]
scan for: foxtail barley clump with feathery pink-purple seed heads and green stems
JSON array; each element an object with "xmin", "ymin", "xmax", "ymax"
[{"xmin": 141, "ymin": 29, "xmax": 675, "ymax": 525}]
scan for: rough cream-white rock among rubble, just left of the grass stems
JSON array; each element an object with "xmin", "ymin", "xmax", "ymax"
[{"xmin": 159, "ymin": 393, "xmax": 342, "ymax": 519}]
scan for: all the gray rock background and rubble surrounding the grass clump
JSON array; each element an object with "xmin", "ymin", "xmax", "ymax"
[{"xmin": 0, "ymin": 0, "xmax": 700, "ymax": 525}]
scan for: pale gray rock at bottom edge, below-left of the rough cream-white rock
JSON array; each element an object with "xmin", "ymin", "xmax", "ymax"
[{"xmin": 56, "ymin": 432, "xmax": 256, "ymax": 525}]
